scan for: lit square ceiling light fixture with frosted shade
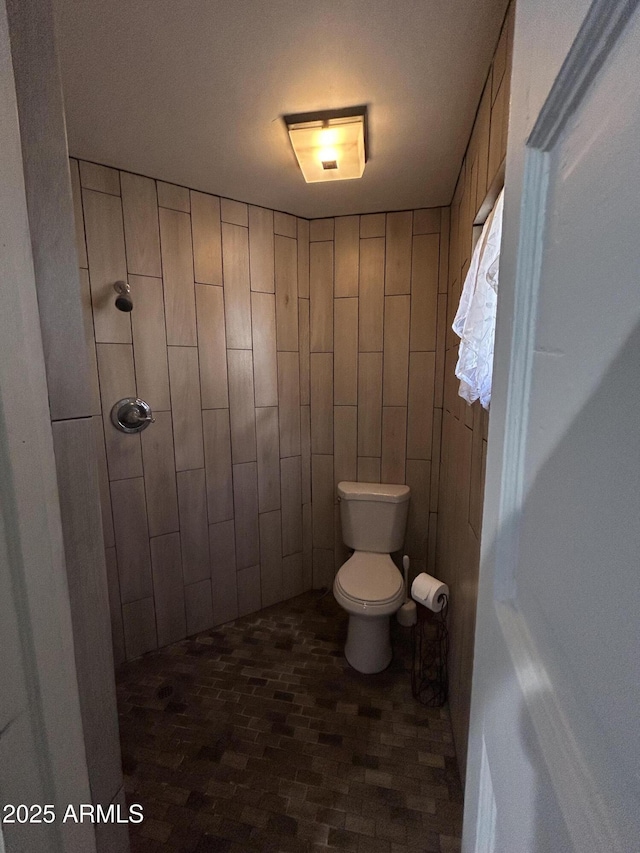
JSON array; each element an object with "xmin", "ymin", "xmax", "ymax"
[{"xmin": 283, "ymin": 106, "xmax": 367, "ymax": 184}]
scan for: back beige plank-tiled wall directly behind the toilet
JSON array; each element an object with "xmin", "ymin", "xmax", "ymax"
[{"xmin": 302, "ymin": 208, "xmax": 449, "ymax": 587}]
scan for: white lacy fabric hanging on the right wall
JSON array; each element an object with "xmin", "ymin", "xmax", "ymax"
[{"xmin": 452, "ymin": 190, "xmax": 504, "ymax": 409}]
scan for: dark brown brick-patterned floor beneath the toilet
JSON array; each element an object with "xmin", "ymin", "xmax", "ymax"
[{"xmin": 117, "ymin": 593, "xmax": 462, "ymax": 853}]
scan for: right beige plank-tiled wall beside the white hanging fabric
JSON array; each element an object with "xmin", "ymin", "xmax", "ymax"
[{"xmin": 436, "ymin": 4, "xmax": 514, "ymax": 776}]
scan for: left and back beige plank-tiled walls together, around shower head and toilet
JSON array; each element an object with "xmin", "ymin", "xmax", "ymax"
[{"xmin": 71, "ymin": 160, "xmax": 449, "ymax": 661}]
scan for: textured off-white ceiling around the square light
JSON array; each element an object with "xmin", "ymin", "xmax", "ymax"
[{"xmin": 54, "ymin": 0, "xmax": 506, "ymax": 218}]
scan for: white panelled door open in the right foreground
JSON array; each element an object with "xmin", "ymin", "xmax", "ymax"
[{"xmin": 463, "ymin": 0, "xmax": 640, "ymax": 853}]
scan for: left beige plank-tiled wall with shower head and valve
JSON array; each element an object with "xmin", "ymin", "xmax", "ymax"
[{"xmin": 71, "ymin": 160, "xmax": 312, "ymax": 662}]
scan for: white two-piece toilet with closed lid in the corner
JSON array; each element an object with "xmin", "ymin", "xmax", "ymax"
[{"xmin": 333, "ymin": 482, "xmax": 410, "ymax": 673}]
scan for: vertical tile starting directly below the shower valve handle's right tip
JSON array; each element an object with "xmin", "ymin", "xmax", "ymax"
[{"xmin": 140, "ymin": 412, "xmax": 180, "ymax": 536}]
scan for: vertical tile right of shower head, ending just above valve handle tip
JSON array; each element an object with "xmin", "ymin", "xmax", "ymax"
[{"xmin": 129, "ymin": 275, "xmax": 171, "ymax": 412}]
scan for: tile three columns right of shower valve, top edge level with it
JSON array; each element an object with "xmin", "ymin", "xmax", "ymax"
[{"xmin": 202, "ymin": 409, "xmax": 233, "ymax": 524}]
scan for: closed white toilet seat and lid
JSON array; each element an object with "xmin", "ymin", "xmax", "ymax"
[{"xmin": 334, "ymin": 551, "xmax": 404, "ymax": 616}]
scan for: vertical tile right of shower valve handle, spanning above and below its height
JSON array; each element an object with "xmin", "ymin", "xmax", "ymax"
[{"xmin": 168, "ymin": 347, "xmax": 204, "ymax": 471}]
